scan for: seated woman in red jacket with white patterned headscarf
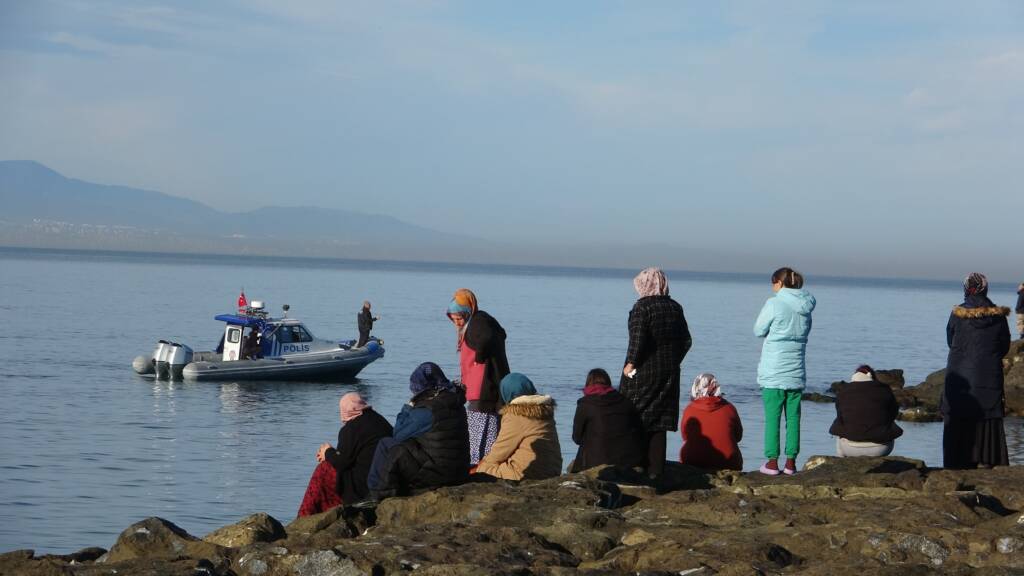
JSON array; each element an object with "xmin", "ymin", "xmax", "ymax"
[{"xmin": 679, "ymin": 373, "xmax": 743, "ymax": 470}]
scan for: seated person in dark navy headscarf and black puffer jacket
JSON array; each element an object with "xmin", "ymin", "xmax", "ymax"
[{"xmin": 368, "ymin": 362, "xmax": 469, "ymax": 500}]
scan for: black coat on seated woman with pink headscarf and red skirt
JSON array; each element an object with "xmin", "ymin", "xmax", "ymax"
[{"xmin": 326, "ymin": 408, "xmax": 392, "ymax": 504}]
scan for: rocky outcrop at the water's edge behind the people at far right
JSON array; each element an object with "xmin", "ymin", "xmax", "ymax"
[{"xmin": 804, "ymin": 340, "xmax": 1024, "ymax": 422}]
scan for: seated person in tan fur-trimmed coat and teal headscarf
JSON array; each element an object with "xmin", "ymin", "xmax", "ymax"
[{"xmin": 476, "ymin": 372, "xmax": 562, "ymax": 480}]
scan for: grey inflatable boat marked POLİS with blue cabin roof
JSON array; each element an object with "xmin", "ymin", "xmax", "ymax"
[{"xmin": 132, "ymin": 296, "xmax": 384, "ymax": 380}]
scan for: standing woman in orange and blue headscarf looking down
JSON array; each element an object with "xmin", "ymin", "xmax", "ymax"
[{"xmin": 447, "ymin": 288, "xmax": 509, "ymax": 464}]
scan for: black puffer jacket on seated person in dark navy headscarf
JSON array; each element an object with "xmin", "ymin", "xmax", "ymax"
[{"xmin": 374, "ymin": 388, "xmax": 469, "ymax": 497}]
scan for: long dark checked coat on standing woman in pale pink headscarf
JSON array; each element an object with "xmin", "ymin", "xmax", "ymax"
[{"xmin": 618, "ymin": 296, "xmax": 693, "ymax": 431}]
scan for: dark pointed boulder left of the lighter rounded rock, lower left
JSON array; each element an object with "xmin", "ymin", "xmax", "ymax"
[{"xmin": 104, "ymin": 517, "xmax": 226, "ymax": 564}]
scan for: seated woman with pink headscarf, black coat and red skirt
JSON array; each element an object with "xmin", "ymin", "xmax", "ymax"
[{"xmin": 298, "ymin": 392, "xmax": 392, "ymax": 517}]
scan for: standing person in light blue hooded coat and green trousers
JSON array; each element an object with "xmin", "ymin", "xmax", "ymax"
[{"xmin": 754, "ymin": 268, "xmax": 816, "ymax": 476}]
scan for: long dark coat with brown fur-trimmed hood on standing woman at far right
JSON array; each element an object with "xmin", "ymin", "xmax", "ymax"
[{"xmin": 940, "ymin": 296, "xmax": 1010, "ymax": 420}]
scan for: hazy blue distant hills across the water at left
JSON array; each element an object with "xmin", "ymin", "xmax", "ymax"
[{"xmin": 0, "ymin": 161, "xmax": 465, "ymax": 253}]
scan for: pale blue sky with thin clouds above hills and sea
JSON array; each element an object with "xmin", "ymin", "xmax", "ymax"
[{"xmin": 0, "ymin": 0, "xmax": 1024, "ymax": 281}]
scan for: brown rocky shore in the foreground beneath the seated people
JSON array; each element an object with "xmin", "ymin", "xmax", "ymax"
[{"xmin": 6, "ymin": 457, "xmax": 1024, "ymax": 576}]
